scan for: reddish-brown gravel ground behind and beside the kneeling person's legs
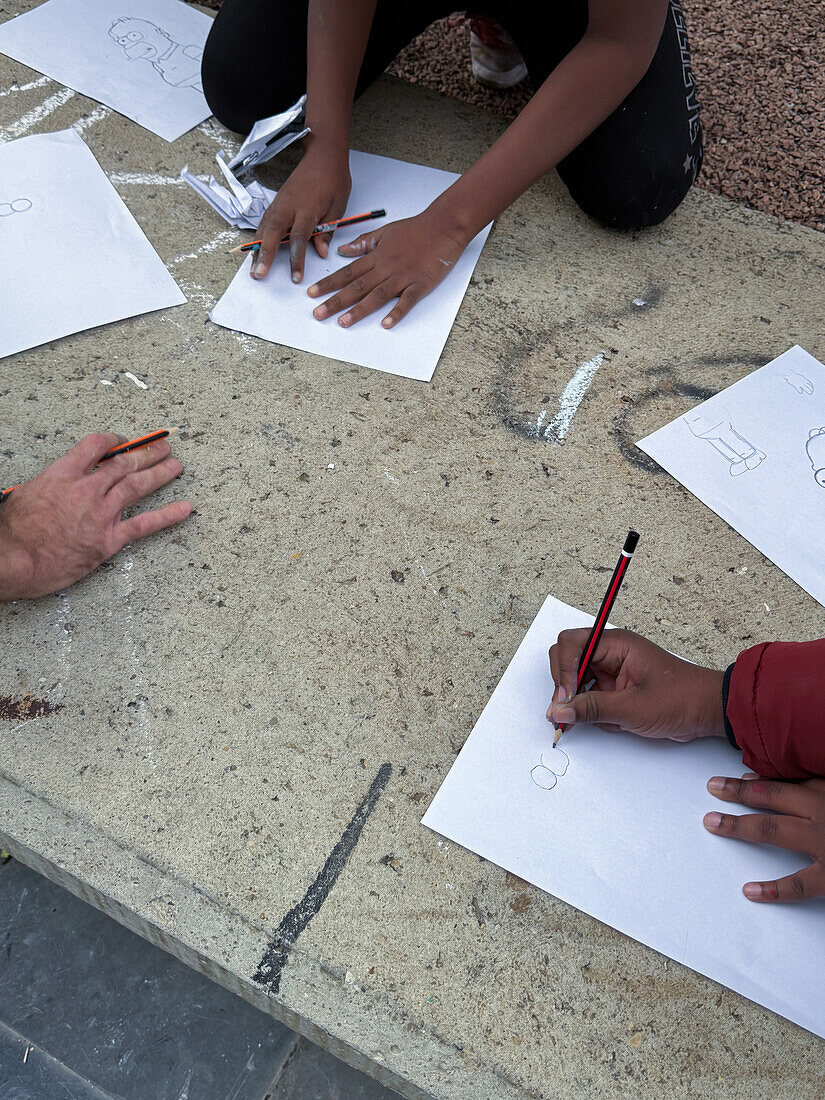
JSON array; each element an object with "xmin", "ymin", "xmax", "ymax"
[{"xmin": 196, "ymin": 0, "xmax": 825, "ymax": 231}]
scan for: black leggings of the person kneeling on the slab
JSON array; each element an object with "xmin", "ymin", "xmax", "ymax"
[{"xmin": 202, "ymin": 0, "xmax": 702, "ymax": 229}]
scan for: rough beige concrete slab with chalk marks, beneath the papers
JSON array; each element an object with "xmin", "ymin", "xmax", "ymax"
[{"xmin": 0, "ymin": 0, "xmax": 825, "ymax": 1100}]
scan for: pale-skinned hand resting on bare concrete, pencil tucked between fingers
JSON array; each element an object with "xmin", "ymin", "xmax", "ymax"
[{"xmin": 0, "ymin": 432, "xmax": 193, "ymax": 600}]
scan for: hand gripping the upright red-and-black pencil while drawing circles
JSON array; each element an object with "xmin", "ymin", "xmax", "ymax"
[{"xmin": 547, "ymin": 628, "xmax": 725, "ymax": 741}]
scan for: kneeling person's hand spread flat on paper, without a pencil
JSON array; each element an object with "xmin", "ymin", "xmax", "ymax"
[{"xmin": 307, "ymin": 208, "xmax": 469, "ymax": 329}]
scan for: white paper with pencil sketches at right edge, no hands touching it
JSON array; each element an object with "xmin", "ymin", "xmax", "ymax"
[{"xmin": 637, "ymin": 347, "xmax": 825, "ymax": 604}]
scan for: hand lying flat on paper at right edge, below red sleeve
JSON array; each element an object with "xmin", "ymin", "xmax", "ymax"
[{"xmin": 704, "ymin": 772, "xmax": 825, "ymax": 901}]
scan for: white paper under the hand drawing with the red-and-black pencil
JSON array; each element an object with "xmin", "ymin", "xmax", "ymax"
[{"xmin": 424, "ymin": 596, "xmax": 825, "ymax": 1036}]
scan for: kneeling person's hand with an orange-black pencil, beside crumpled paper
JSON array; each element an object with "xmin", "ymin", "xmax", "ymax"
[{"xmin": 251, "ymin": 135, "xmax": 352, "ymax": 283}]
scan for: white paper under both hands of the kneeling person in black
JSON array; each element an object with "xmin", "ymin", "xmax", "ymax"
[{"xmin": 209, "ymin": 152, "xmax": 490, "ymax": 382}]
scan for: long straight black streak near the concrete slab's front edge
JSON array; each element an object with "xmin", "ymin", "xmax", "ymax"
[{"xmin": 252, "ymin": 763, "xmax": 393, "ymax": 994}]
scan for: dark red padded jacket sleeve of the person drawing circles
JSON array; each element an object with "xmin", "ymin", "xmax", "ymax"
[{"xmin": 725, "ymin": 638, "xmax": 825, "ymax": 779}]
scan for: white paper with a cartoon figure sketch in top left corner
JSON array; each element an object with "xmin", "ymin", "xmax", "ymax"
[{"xmin": 0, "ymin": 0, "xmax": 212, "ymax": 141}]
